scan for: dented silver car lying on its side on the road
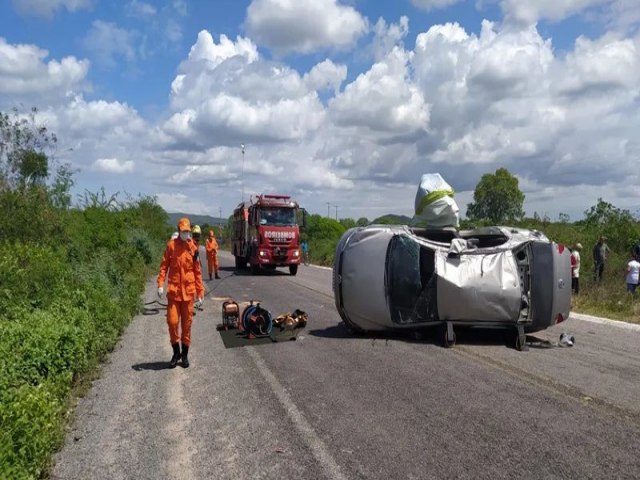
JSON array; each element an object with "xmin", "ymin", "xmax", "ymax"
[{"xmin": 333, "ymin": 225, "xmax": 571, "ymax": 350}]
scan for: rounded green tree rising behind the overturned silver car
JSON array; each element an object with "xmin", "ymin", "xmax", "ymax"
[{"xmin": 467, "ymin": 168, "xmax": 524, "ymax": 224}]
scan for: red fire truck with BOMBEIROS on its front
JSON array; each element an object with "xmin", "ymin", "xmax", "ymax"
[{"xmin": 232, "ymin": 195, "xmax": 304, "ymax": 275}]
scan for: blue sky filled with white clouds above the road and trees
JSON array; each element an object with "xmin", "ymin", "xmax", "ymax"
[{"xmin": 0, "ymin": 0, "xmax": 640, "ymax": 219}]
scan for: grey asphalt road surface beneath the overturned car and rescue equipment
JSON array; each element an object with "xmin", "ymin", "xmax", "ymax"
[{"xmin": 52, "ymin": 251, "xmax": 640, "ymax": 480}]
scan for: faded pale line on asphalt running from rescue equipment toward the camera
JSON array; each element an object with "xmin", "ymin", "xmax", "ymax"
[{"xmin": 245, "ymin": 347, "xmax": 347, "ymax": 480}]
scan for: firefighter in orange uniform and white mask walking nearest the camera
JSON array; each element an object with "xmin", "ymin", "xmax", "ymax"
[{"xmin": 158, "ymin": 218, "xmax": 204, "ymax": 368}]
